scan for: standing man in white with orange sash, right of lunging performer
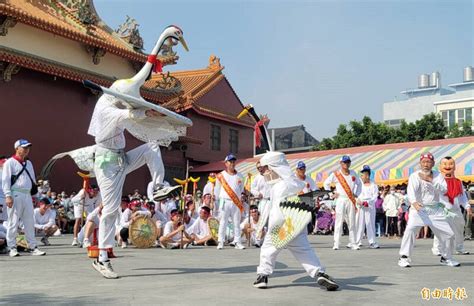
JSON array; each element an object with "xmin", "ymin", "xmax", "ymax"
[{"xmin": 324, "ymin": 155, "xmax": 362, "ymax": 250}]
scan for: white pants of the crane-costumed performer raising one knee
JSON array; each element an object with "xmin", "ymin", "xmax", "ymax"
[{"xmin": 94, "ymin": 143, "xmax": 164, "ymax": 249}]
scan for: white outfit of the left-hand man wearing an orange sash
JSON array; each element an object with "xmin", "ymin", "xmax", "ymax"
[{"xmin": 216, "ymin": 170, "xmax": 244, "ymax": 244}]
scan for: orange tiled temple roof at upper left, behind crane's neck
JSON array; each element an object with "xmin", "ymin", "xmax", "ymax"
[{"xmin": 0, "ymin": 0, "xmax": 177, "ymax": 65}]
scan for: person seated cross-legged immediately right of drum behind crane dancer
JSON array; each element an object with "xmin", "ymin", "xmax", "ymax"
[{"xmin": 160, "ymin": 209, "xmax": 193, "ymax": 249}]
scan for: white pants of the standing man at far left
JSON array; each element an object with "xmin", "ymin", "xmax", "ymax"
[{"xmin": 6, "ymin": 192, "xmax": 36, "ymax": 249}]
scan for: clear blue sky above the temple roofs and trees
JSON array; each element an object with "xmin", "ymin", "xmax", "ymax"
[{"xmin": 94, "ymin": 0, "xmax": 474, "ymax": 139}]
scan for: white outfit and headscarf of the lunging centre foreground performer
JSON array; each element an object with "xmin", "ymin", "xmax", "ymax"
[{"xmin": 257, "ymin": 152, "xmax": 324, "ymax": 277}]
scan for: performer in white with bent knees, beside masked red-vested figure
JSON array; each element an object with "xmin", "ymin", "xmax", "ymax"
[{"xmin": 398, "ymin": 153, "xmax": 460, "ymax": 268}]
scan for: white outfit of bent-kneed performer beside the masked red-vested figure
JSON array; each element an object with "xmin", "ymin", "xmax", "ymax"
[{"xmin": 400, "ymin": 170, "xmax": 454, "ymax": 259}]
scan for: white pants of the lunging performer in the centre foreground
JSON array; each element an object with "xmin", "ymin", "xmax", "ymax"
[{"xmin": 257, "ymin": 230, "xmax": 324, "ymax": 277}]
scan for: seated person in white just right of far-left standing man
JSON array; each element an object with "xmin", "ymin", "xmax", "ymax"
[{"xmin": 33, "ymin": 198, "xmax": 61, "ymax": 245}]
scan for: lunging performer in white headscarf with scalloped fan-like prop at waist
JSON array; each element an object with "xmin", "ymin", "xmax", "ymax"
[{"xmin": 254, "ymin": 152, "xmax": 339, "ymax": 291}]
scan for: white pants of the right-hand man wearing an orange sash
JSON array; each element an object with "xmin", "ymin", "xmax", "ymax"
[{"xmin": 334, "ymin": 196, "xmax": 356, "ymax": 247}]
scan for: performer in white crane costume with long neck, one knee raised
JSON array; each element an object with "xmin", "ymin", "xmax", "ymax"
[{"xmin": 41, "ymin": 26, "xmax": 192, "ymax": 278}]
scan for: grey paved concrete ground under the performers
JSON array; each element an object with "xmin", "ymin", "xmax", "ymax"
[{"xmin": 0, "ymin": 236, "xmax": 474, "ymax": 305}]
